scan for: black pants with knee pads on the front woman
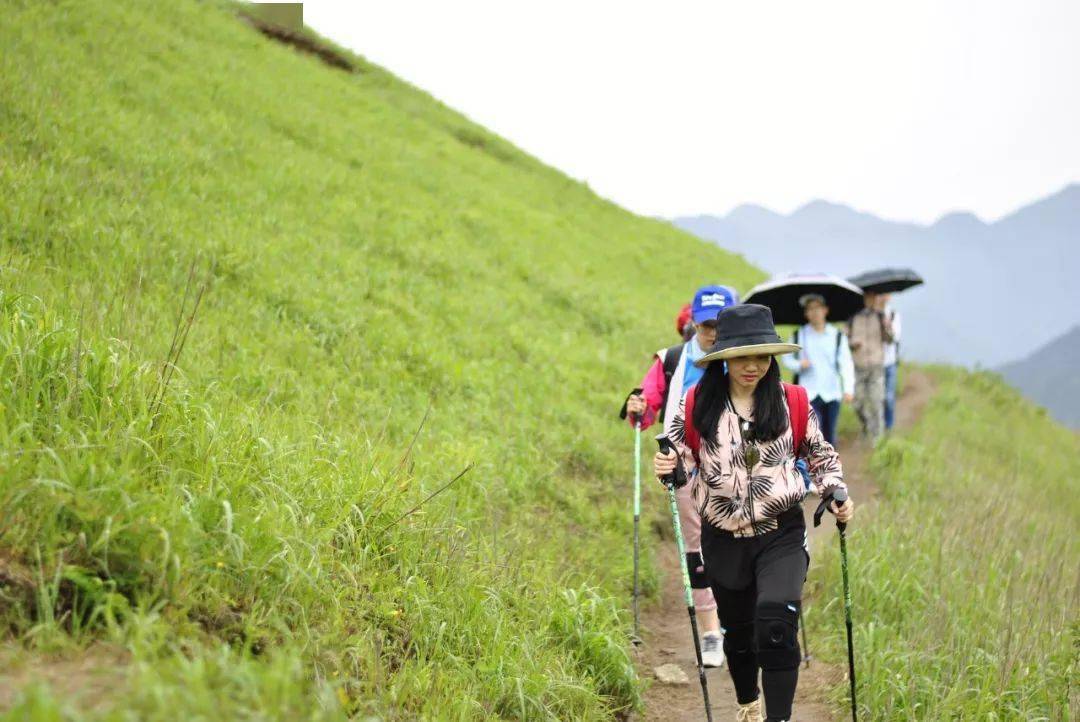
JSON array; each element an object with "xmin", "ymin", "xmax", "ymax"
[{"xmin": 701, "ymin": 506, "xmax": 810, "ymax": 720}]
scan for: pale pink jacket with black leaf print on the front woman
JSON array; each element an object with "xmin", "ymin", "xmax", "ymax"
[{"xmin": 671, "ymin": 388, "xmax": 846, "ymax": 536}]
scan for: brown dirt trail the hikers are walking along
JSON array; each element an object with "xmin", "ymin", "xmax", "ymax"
[{"xmin": 636, "ymin": 370, "xmax": 933, "ymax": 722}]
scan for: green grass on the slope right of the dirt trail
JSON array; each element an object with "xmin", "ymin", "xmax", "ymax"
[{"xmin": 808, "ymin": 368, "xmax": 1080, "ymax": 720}]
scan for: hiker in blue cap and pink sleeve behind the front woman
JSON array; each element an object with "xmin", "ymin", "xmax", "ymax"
[{"xmin": 620, "ymin": 286, "xmax": 739, "ymax": 667}]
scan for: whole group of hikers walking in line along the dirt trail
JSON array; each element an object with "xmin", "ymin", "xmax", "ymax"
[{"xmin": 622, "ymin": 285, "xmax": 900, "ymax": 722}]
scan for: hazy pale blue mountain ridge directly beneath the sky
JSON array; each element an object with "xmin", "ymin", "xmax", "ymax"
[{"xmin": 672, "ymin": 183, "xmax": 1080, "ymax": 368}]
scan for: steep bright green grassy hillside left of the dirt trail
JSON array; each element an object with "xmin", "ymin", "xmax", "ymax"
[{"xmin": 0, "ymin": 0, "xmax": 760, "ymax": 720}]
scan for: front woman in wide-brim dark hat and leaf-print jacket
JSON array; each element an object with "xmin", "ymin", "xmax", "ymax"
[{"xmin": 653, "ymin": 304, "xmax": 854, "ymax": 721}]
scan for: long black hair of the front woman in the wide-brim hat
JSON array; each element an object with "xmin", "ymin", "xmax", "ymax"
[{"xmin": 693, "ymin": 357, "xmax": 788, "ymax": 444}]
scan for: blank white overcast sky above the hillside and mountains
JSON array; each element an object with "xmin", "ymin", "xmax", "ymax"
[{"xmin": 305, "ymin": 0, "xmax": 1080, "ymax": 222}]
